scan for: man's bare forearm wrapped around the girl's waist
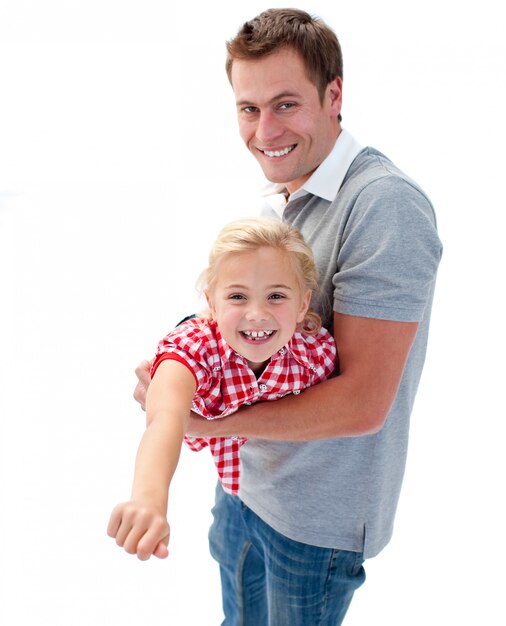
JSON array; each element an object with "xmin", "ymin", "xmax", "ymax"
[{"xmin": 189, "ymin": 313, "xmax": 418, "ymax": 441}]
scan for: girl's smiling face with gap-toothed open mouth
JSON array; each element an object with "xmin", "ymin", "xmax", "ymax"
[{"xmin": 206, "ymin": 246, "xmax": 311, "ymax": 373}]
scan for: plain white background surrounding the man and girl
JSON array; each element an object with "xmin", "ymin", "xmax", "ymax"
[{"xmin": 0, "ymin": 0, "xmax": 506, "ymax": 626}]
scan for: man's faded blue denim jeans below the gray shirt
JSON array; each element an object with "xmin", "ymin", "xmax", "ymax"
[{"xmin": 209, "ymin": 485, "xmax": 365, "ymax": 626}]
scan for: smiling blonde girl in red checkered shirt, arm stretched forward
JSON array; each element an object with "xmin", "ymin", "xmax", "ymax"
[{"xmin": 108, "ymin": 218, "xmax": 336, "ymax": 560}]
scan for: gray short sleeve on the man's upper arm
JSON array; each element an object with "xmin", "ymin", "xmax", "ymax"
[{"xmin": 333, "ymin": 175, "xmax": 442, "ymax": 321}]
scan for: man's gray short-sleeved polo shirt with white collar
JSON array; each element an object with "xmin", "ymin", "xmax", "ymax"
[{"xmin": 240, "ymin": 131, "xmax": 442, "ymax": 558}]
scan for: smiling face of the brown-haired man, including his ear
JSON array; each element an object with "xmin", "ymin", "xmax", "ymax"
[{"xmin": 231, "ymin": 48, "xmax": 342, "ymax": 193}]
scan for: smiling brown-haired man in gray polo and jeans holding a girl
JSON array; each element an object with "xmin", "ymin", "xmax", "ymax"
[{"xmin": 132, "ymin": 9, "xmax": 441, "ymax": 626}]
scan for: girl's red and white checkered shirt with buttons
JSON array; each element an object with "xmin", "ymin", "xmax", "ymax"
[{"xmin": 151, "ymin": 319, "xmax": 336, "ymax": 495}]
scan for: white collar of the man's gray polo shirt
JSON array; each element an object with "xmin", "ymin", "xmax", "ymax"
[{"xmin": 263, "ymin": 128, "xmax": 363, "ymax": 217}]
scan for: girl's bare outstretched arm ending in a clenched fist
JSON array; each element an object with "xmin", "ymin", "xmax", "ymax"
[{"xmin": 107, "ymin": 360, "xmax": 196, "ymax": 560}]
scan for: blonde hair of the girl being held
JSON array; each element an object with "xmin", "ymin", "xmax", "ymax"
[{"xmin": 197, "ymin": 217, "xmax": 322, "ymax": 335}]
